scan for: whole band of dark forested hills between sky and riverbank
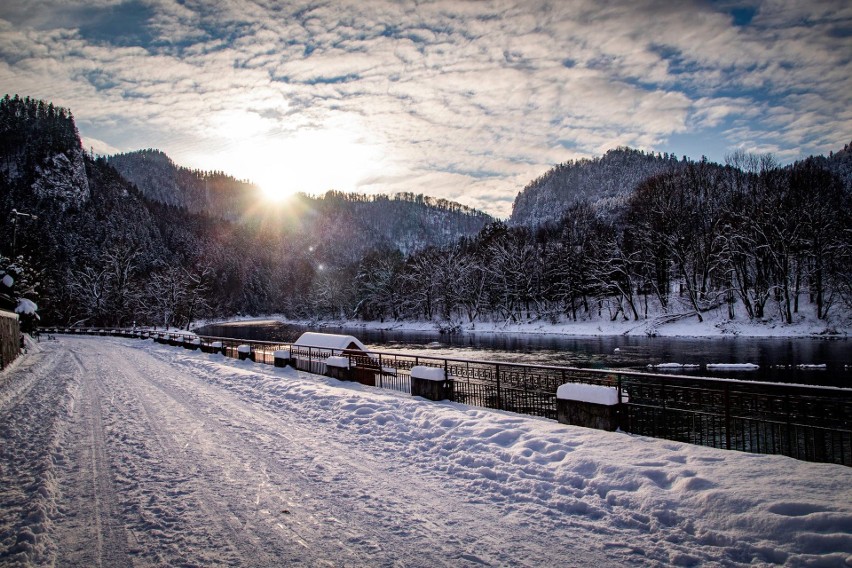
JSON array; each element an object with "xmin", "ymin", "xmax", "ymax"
[{"xmin": 0, "ymin": 95, "xmax": 852, "ymax": 327}]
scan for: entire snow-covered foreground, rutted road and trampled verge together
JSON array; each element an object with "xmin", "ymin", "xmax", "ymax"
[{"xmin": 0, "ymin": 337, "xmax": 852, "ymax": 567}]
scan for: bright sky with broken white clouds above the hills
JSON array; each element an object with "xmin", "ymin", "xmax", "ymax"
[{"xmin": 0, "ymin": 0, "xmax": 852, "ymax": 216}]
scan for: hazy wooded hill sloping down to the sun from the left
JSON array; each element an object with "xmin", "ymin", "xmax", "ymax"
[{"xmin": 107, "ymin": 149, "xmax": 260, "ymax": 220}]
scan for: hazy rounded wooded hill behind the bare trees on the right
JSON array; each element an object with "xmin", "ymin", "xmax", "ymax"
[{"xmin": 509, "ymin": 148, "xmax": 685, "ymax": 226}]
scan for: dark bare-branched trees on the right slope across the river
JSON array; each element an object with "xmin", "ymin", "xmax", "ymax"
[{"xmin": 374, "ymin": 155, "xmax": 852, "ymax": 330}]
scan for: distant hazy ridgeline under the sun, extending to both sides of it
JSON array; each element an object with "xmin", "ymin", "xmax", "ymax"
[{"xmin": 107, "ymin": 150, "xmax": 494, "ymax": 255}]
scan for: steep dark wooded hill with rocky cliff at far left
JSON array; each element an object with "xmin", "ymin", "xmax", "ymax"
[{"xmin": 0, "ymin": 95, "xmax": 171, "ymax": 323}]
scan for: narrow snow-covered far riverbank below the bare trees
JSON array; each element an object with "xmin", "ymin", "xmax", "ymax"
[{"xmin": 201, "ymin": 308, "xmax": 852, "ymax": 339}]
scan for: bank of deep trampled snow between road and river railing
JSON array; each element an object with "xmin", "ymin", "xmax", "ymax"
[{"xmin": 167, "ymin": 344, "xmax": 852, "ymax": 566}]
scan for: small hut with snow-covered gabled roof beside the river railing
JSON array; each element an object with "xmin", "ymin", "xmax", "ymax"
[{"xmin": 290, "ymin": 331, "xmax": 381, "ymax": 385}]
